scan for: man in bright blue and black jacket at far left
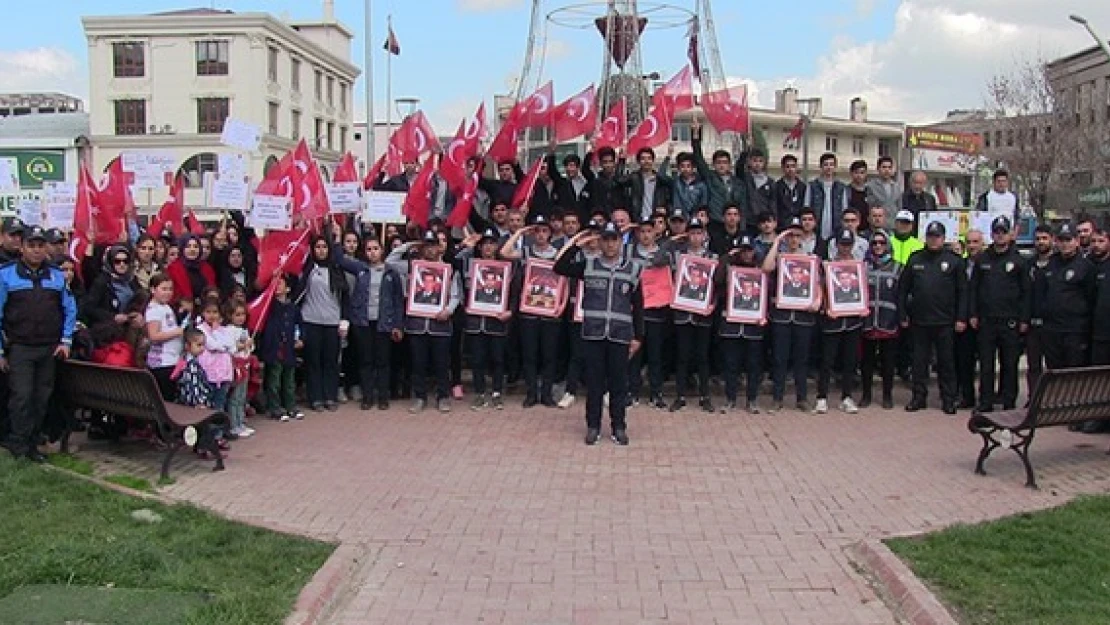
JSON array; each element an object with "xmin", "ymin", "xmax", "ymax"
[{"xmin": 0, "ymin": 225, "xmax": 77, "ymax": 462}]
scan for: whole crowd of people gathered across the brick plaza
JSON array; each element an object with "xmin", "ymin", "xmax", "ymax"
[{"xmin": 0, "ymin": 128, "xmax": 1110, "ymax": 460}]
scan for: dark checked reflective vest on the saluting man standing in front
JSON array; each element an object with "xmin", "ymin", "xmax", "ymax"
[{"xmin": 582, "ymin": 256, "xmax": 642, "ymax": 343}]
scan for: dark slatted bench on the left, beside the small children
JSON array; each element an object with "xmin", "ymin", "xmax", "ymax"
[{"xmin": 54, "ymin": 361, "xmax": 228, "ymax": 480}]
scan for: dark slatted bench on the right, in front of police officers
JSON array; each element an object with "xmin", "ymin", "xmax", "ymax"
[{"xmin": 968, "ymin": 366, "xmax": 1110, "ymax": 488}]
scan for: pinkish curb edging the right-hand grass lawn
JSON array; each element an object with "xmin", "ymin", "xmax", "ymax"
[{"xmin": 847, "ymin": 538, "xmax": 959, "ymax": 625}]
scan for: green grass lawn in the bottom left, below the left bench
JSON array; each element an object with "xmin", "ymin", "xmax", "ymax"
[{"xmin": 0, "ymin": 453, "xmax": 334, "ymax": 625}]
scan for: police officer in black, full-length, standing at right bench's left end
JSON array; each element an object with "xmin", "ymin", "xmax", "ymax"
[{"xmin": 968, "ymin": 216, "xmax": 1030, "ymax": 412}]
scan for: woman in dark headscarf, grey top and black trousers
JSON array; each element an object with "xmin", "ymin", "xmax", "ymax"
[{"xmin": 295, "ymin": 235, "xmax": 347, "ymax": 411}]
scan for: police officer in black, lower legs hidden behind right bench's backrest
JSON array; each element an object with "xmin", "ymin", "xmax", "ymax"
[{"xmin": 1041, "ymin": 223, "xmax": 1097, "ymax": 369}]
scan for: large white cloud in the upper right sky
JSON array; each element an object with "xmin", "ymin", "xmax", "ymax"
[{"xmin": 749, "ymin": 0, "xmax": 1110, "ymax": 123}]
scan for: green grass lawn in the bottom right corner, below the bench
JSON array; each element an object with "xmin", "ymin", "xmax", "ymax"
[{"xmin": 887, "ymin": 496, "xmax": 1110, "ymax": 625}]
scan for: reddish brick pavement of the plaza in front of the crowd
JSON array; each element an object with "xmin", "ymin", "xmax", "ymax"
[{"xmin": 147, "ymin": 390, "xmax": 1110, "ymax": 625}]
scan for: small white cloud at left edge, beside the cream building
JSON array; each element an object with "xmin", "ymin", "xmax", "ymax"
[{"xmin": 0, "ymin": 48, "xmax": 89, "ymax": 99}]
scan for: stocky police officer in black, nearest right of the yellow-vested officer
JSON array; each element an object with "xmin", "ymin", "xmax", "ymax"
[{"xmin": 898, "ymin": 221, "xmax": 968, "ymax": 414}]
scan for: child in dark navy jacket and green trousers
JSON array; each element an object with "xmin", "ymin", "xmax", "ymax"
[{"xmin": 259, "ymin": 275, "xmax": 304, "ymax": 421}]
